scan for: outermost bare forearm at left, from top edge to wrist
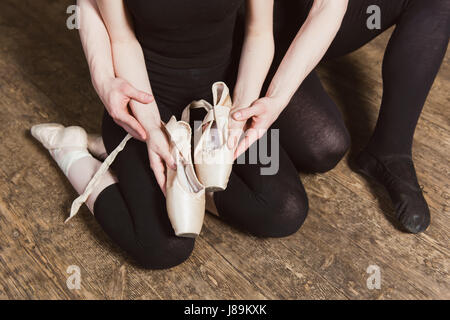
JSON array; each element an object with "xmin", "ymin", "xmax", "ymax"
[{"xmin": 77, "ymin": 0, "xmax": 115, "ymax": 96}]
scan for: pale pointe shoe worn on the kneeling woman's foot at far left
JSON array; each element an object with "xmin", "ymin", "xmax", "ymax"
[{"xmin": 31, "ymin": 123, "xmax": 90, "ymax": 176}]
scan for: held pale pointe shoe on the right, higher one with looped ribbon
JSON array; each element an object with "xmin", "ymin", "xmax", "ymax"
[{"xmin": 181, "ymin": 82, "xmax": 234, "ymax": 191}]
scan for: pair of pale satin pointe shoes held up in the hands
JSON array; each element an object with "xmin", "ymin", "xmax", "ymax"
[{"xmin": 165, "ymin": 82, "xmax": 234, "ymax": 237}]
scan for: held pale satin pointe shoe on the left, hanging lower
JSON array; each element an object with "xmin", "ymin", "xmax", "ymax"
[{"xmin": 165, "ymin": 117, "xmax": 205, "ymax": 238}]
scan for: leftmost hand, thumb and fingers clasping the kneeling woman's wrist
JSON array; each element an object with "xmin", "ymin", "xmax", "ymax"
[{"xmin": 98, "ymin": 78, "xmax": 154, "ymax": 141}]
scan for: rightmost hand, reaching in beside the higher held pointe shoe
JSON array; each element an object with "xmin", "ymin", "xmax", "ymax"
[{"xmin": 231, "ymin": 97, "xmax": 285, "ymax": 159}]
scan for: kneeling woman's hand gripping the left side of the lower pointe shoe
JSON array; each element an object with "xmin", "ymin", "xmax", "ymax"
[{"xmin": 146, "ymin": 124, "xmax": 177, "ymax": 195}]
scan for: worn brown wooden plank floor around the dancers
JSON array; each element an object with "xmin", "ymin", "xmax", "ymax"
[{"xmin": 0, "ymin": 0, "xmax": 450, "ymax": 299}]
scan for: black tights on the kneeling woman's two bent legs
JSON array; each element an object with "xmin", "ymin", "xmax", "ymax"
[{"xmin": 94, "ymin": 104, "xmax": 308, "ymax": 269}]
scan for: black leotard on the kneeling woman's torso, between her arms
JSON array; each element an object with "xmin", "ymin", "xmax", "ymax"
[{"xmin": 125, "ymin": 0, "xmax": 244, "ymax": 110}]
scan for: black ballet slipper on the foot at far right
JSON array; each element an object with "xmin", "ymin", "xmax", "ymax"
[{"xmin": 354, "ymin": 150, "xmax": 430, "ymax": 233}]
